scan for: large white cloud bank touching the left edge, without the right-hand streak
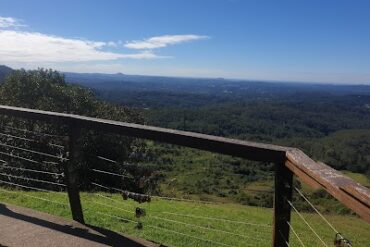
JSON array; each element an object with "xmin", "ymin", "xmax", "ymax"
[{"xmin": 0, "ymin": 30, "xmax": 163, "ymax": 63}]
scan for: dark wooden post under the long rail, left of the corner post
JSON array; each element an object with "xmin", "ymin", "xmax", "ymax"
[{"xmin": 64, "ymin": 125, "xmax": 85, "ymax": 224}]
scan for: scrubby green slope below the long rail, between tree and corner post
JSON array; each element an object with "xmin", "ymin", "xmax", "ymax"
[{"xmin": 150, "ymin": 146, "xmax": 273, "ymax": 203}]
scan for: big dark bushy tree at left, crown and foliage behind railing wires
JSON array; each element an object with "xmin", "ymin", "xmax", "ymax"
[{"xmin": 0, "ymin": 69, "xmax": 160, "ymax": 192}]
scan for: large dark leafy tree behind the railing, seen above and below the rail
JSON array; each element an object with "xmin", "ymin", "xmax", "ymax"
[{"xmin": 0, "ymin": 69, "xmax": 160, "ymax": 195}]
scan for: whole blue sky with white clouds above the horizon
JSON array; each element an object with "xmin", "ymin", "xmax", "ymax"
[{"xmin": 0, "ymin": 0, "xmax": 370, "ymax": 84}]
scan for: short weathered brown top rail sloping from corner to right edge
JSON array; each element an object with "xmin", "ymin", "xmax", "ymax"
[{"xmin": 285, "ymin": 149, "xmax": 370, "ymax": 222}]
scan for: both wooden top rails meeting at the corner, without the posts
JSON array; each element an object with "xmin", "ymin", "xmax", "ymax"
[{"xmin": 0, "ymin": 105, "xmax": 370, "ymax": 222}]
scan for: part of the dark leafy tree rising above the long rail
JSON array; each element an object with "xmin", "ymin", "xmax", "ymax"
[{"xmin": 0, "ymin": 69, "xmax": 142, "ymax": 122}]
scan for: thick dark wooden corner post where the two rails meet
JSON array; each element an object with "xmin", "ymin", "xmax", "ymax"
[{"xmin": 272, "ymin": 163, "xmax": 293, "ymax": 247}]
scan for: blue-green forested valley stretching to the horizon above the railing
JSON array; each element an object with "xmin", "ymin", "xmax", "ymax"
[{"xmin": 66, "ymin": 73, "xmax": 370, "ymax": 176}]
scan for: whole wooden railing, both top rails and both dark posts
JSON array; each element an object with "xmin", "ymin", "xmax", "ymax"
[{"xmin": 0, "ymin": 105, "xmax": 370, "ymax": 247}]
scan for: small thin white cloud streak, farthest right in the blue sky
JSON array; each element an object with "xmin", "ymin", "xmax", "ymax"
[{"xmin": 125, "ymin": 34, "xmax": 209, "ymax": 49}]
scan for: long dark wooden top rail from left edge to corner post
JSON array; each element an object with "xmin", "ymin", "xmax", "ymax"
[{"xmin": 0, "ymin": 105, "xmax": 289, "ymax": 163}]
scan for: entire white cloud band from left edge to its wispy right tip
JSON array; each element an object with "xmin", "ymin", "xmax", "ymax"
[{"xmin": 0, "ymin": 16, "xmax": 208, "ymax": 63}]
